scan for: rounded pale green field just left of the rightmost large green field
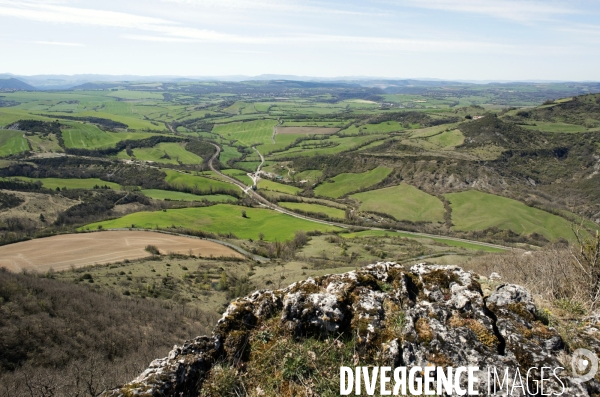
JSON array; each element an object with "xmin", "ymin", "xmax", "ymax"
[{"xmin": 350, "ymin": 183, "xmax": 445, "ymax": 222}]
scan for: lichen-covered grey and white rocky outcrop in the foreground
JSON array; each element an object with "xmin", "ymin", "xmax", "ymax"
[{"xmin": 104, "ymin": 263, "xmax": 600, "ymax": 397}]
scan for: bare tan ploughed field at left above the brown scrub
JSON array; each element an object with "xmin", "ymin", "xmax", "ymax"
[{"xmin": 0, "ymin": 231, "xmax": 243, "ymax": 272}]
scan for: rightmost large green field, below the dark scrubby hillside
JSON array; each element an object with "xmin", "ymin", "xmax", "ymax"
[{"xmin": 445, "ymin": 190, "xmax": 574, "ymax": 240}]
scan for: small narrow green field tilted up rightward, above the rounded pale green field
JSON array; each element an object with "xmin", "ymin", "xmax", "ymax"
[{"xmin": 315, "ymin": 167, "xmax": 392, "ymax": 198}]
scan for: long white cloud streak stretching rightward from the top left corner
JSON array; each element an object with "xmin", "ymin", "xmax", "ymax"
[{"xmin": 0, "ymin": 0, "xmax": 568, "ymax": 53}]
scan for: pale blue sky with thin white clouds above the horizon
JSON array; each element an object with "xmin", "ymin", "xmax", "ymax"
[{"xmin": 0, "ymin": 0, "xmax": 600, "ymax": 81}]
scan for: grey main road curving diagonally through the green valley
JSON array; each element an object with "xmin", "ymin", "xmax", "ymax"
[{"xmin": 208, "ymin": 143, "xmax": 514, "ymax": 250}]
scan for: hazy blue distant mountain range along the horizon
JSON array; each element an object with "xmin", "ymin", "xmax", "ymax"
[{"xmin": 0, "ymin": 73, "xmax": 596, "ymax": 90}]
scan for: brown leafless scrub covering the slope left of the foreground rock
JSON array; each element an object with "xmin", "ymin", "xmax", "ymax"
[{"xmin": 0, "ymin": 270, "xmax": 216, "ymax": 397}]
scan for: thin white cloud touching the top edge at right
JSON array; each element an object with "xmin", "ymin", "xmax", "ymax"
[{"xmin": 404, "ymin": 0, "xmax": 579, "ymax": 22}]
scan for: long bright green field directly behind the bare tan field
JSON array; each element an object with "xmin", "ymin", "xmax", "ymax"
[{"xmin": 80, "ymin": 204, "xmax": 340, "ymax": 241}]
